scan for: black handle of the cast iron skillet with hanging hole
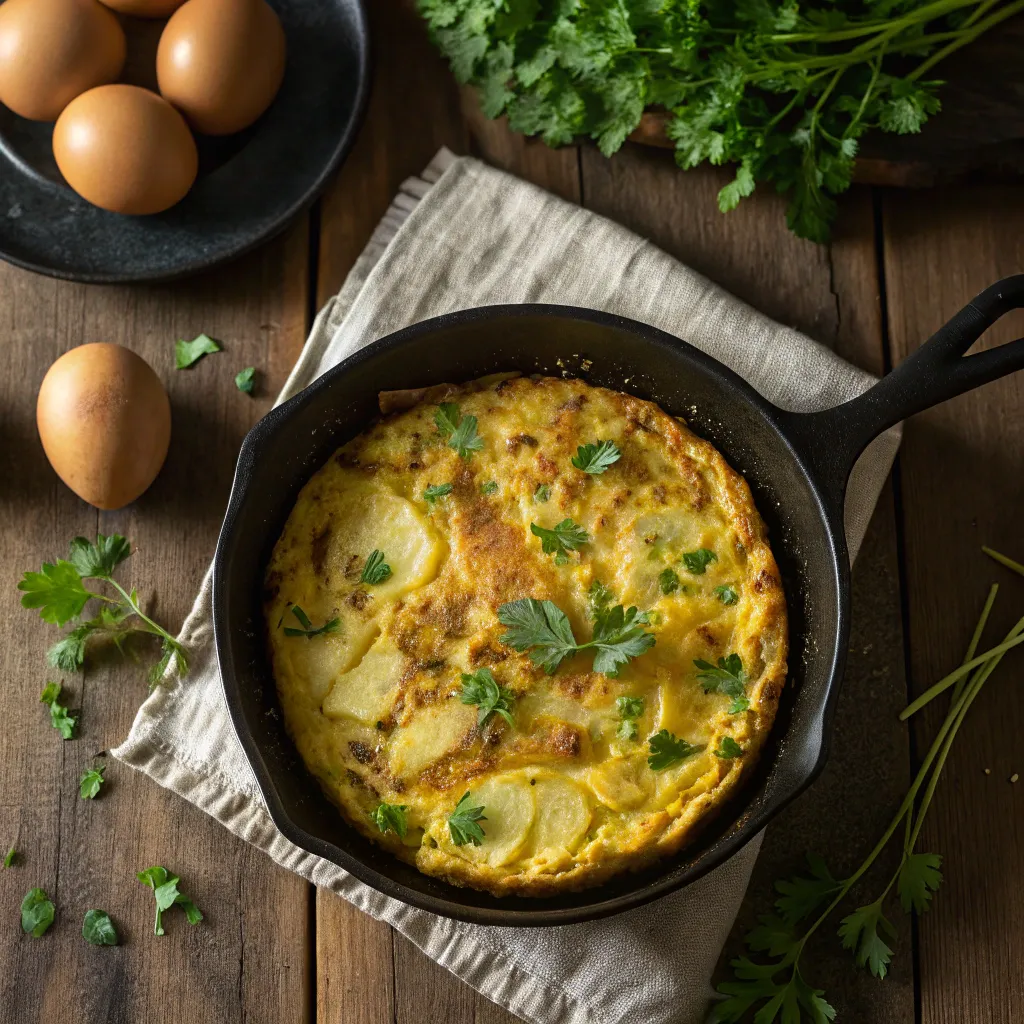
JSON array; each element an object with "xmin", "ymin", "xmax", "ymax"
[{"xmin": 783, "ymin": 274, "xmax": 1024, "ymax": 519}]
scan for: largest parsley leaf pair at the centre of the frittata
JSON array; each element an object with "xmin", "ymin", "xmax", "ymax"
[{"xmin": 498, "ymin": 597, "xmax": 654, "ymax": 678}]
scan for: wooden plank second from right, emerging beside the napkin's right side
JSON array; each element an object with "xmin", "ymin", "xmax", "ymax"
[{"xmin": 583, "ymin": 145, "xmax": 913, "ymax": 1022}]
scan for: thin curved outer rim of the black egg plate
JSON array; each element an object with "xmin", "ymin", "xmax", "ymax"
[{"xmin": 0, "ymin": 0, "xmax": 373, "ymax": 285}]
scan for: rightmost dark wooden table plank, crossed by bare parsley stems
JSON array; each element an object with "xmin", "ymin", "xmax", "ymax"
[{"xmin": 884, "ymin": 187, "xmax": 1024, "ymax": 1024}]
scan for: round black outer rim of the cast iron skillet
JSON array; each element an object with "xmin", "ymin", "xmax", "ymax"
[{"xmin": 212, "ymin": 303, "xmax": 850, "ymax": 927}]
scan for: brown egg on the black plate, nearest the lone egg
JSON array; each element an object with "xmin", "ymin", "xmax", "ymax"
[{"xmin": 53, "ymin": 85, "xmax": 199, "ymax": 214}]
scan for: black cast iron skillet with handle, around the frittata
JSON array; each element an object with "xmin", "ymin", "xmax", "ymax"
[{"xmin": 213, "ymin": 274, "xmax": 1024, "ymax": 925}]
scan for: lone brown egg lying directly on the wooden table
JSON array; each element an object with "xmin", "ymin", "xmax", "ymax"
[{"xmin": 36, "ymin": 342, "xmax": 171, "ymax": 509}]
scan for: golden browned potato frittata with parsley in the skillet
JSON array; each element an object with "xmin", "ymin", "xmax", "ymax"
[{"xmin": 264, "ymin": 376, "xmax": 786, "ymax": 896}]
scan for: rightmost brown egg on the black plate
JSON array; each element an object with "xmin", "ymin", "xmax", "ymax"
[{"xmin": 157, "ymin": 0, "xmax": 285, "ymax": 135}]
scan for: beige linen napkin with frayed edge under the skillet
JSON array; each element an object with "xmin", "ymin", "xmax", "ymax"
[{"xmin": 113, "ymin": 150, "xmax": 899, "ymax": 1024}]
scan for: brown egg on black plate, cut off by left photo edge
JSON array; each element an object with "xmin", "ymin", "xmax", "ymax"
[{"xmin": 0, "ymin": 0, "xmax": 125, "ymax": 121}]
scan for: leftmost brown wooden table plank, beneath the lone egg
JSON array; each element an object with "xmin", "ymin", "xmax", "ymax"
[{"xmin": 0, "ymin": 221, "xmax": 311, "ymax": 1022}]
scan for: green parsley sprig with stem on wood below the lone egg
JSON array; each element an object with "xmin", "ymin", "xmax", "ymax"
[{"xmin": 17, "ymin": 534, "xmax": 187, "ymax": 691}]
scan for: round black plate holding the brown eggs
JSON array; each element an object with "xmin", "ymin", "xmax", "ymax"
[{"xmin": 0, "ymin": 0, "xmax": 370, "ymax": 282}]
